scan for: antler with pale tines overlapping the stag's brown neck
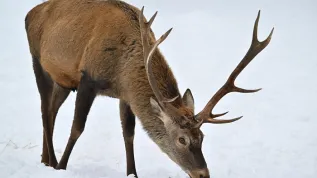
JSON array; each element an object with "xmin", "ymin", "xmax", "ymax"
[{"xmin": 139, "ymin": 6, "xmax": 178, "ymax": 106}]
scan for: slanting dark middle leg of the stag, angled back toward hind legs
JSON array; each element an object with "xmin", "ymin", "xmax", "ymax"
[{"xmin": 56, "ymin": 72, "xmax": 99, "ymax": 169}]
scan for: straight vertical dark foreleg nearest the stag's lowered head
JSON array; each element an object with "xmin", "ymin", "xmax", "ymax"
[{"xmin": 120, "ymin": 100, "xmax": 137, "ymax": 177}]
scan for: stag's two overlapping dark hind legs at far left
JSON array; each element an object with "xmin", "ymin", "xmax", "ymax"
[{"xmin": 33, "ymin": 57, "xmax": 69, "ymax": 167}]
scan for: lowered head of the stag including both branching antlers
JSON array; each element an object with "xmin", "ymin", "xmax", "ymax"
[{"xmin": 139, "ymin": 7, "xmax": 274, "ymax": 178}]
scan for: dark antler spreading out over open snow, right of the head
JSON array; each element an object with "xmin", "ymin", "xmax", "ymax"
[{"xmin": 195, "ymin": 11, "xmax": 274, "ymax": 127}]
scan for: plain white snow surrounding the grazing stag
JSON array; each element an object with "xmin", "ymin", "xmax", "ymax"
[{"xmin": 0, "ymin": 0, "xmax": 317, "ymax": 178}]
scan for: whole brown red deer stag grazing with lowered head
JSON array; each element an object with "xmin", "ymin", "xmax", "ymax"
[{"xmin": 25, "ymin": 0, "xmax": 273, "ymax": 178}]
